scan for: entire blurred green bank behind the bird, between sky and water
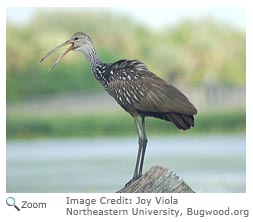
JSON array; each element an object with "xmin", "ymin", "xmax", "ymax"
[{"xmin": 7, "ymin": 8, "xmax": 246, "ymax": 139}]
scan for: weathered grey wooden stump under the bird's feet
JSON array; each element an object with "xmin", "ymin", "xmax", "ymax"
[{"xmin": 117, "ymin": 166, "xmax": 195, "ymax": 193}]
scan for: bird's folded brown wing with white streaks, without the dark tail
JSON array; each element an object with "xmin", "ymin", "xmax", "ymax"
[{"xmin": 105, "ymin": 60, "xmax": 197, "ymax": 115}]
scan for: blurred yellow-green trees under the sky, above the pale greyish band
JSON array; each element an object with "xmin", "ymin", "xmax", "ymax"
[{"xmin": 7, "ymin": 9, "xmax": 246, "ymax": 103}]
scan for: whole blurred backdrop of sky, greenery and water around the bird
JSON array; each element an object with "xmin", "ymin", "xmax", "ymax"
[{"xmin": 6, "ymin": 8, "xmax": 246, "ymax": 192}]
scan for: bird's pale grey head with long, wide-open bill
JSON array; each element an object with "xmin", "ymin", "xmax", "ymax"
[{"xmin": 40, "ymin": 32, "xmax": 92, "ymax": 71}]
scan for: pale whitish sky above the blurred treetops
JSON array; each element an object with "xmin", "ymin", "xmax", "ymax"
[{"xmin": 7, "ymin": 7, "xmax": 246, "ymax": 30}]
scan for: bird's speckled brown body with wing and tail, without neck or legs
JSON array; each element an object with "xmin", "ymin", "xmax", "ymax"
[{"xmin": 105, "ymin": 60, "xmax": 197, "ymax": 130}]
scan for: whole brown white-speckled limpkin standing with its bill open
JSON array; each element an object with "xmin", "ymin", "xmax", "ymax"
[{"xmin": 41, "ymin": 32, "xmax": 197, "ymax": 186}]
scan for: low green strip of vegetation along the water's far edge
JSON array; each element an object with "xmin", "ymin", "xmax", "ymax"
[{"xmin": 7, "ymin": 111, "xmax": 246, "ymax": 139}]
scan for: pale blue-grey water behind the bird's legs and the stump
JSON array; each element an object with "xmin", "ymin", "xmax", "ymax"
[{"xmin": 7, "ymin": 135, "xmax": 246, "ymax": 193}]
